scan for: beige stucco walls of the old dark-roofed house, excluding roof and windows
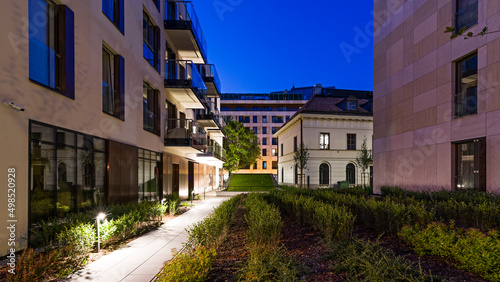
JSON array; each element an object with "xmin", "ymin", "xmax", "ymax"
[{"xmin": 276, "ymin": 114, "xmax": 373, "ymax": 187}]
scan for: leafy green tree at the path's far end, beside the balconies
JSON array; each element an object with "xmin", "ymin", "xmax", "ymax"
[{"xmin": 222, "ymin": 119, "xmax": 260, "ymax": 174}]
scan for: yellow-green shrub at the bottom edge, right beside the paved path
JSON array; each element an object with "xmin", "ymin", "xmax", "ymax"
[{"xmin": 157, "ymin": 246, "xmax": 217, "ymax": 281}]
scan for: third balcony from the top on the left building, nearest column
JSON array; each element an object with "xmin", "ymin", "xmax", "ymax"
[{"xmin": 165, "ymin": 119, "xmax": 207, "ymax": 155}]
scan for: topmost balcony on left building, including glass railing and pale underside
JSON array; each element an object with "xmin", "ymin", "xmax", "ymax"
[{"xmin": 165, "ymin": 0, "xmax": 207, "ymax": 64}]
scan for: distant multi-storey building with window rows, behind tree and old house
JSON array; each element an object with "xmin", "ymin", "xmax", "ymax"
[{"xmin": 221, "ymin": 84, "xmax": 326, "ymax": 174}]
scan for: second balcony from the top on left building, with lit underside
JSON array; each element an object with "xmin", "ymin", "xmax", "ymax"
[{"xmin": 165, "ymin": 60, "xmax": 207, "ymax": 109}]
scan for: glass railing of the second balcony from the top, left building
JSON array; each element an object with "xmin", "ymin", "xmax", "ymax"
[{"xmin": 165, "ymin": 60, "xmax": 207, "ymax": 101}]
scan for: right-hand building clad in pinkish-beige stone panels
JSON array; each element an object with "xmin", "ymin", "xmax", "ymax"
[{"xmin": 374, "ymin": 0, "xmax": 500, "ymax": 192}]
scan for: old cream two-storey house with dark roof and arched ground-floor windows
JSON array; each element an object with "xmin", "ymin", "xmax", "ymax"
[{"xmin": 274, "ymin": 89, "xmax": 373, "ymax": 188}]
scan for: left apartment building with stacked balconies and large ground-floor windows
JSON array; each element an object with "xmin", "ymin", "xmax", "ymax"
[{"xmin": 0, "ymin": 0, "xmax": 224, "ymax": 255}]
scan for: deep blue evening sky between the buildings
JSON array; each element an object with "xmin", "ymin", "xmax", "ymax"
[{"xmin": 193, "ymin": 0, "xmax": 373, "ymax": 93}]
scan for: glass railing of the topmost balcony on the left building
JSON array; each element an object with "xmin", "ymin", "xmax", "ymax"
[{"xmin": 165, "ymin": 0, "xmax": 207, "ymax": 61}]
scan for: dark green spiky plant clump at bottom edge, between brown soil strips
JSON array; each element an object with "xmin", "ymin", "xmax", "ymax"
[{"xmin": 331, "ymin": 240, "xmax": 434, "ymax": 281}]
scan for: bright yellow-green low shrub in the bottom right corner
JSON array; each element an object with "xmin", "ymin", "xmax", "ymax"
[{"xmin": 400, "ymin": 222, "xmax": 500, "ymax": 281}]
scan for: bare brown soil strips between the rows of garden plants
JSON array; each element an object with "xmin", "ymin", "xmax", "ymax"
[{"xmin": 208, "ymin": 202, "xmax": 487, "ymax": 281}]
